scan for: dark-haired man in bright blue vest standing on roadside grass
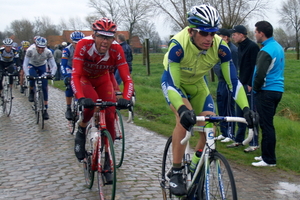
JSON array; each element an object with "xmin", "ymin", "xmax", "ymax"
[{"xmin": 252, "ymin": 21, "xmax": 285, "ymax": 167}]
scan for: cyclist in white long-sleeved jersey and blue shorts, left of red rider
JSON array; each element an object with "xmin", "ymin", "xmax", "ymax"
[{"xmin": 23, "ymin": 37, "xmax": 57, "ymax": 120}]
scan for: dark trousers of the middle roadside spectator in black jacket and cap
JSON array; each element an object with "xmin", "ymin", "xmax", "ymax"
[{"xmin": 235, "ymin": 85, "xmax": 258, "ymax": 146}]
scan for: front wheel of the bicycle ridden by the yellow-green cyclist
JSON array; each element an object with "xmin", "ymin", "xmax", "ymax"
[{"xmin": 198, "ymin": 152, "xmax": 237, "ymax": 200}]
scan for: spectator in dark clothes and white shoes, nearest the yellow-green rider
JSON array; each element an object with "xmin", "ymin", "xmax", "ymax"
[{"xmin": 214, "ymin": 29, "xmax": 238, "ymax": 142}]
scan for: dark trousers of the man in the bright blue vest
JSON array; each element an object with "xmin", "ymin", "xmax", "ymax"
[{"xmin": 255, "ymin": 90, "xmax": 282, "ymax": 164}]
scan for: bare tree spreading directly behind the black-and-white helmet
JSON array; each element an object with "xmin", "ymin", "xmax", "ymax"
[{"xmin": 153, "ymin": 0, "xmax": 270, "ymax": 30}]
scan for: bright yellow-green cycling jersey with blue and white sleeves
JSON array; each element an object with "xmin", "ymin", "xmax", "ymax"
[{"xmin": 162, "ymin": 27, "xmax": 249, "ymax": 114}]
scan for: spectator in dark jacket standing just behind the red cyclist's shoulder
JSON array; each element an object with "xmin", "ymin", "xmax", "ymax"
[{"xmin": 115, "ymin": 34, "xmax": 133, "ymax": 85}]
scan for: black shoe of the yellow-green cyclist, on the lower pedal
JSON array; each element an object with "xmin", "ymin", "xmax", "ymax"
[{"xmin": 170, "ymin": 168, "xmax": 187, "ymax": 196}]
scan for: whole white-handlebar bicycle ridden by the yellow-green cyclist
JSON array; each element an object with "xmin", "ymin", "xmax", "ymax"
[{"xmin": 160, "ymin": 116, "xmax": 254, "ymax": 200}]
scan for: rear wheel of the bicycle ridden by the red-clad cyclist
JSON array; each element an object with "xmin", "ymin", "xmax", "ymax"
[{"xmin": 83, "ymin": 124, "xmax": 96, "ymax": 189}]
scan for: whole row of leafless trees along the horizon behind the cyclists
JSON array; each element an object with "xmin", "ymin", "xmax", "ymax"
[{"xmin": 0, "ymin": 0, "xmax": 300, "ymax": 59}]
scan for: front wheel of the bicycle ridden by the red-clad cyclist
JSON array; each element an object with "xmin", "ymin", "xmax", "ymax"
[{"xmin": 98, "ymin": 130, "xmax": 117, "ymax": 200}]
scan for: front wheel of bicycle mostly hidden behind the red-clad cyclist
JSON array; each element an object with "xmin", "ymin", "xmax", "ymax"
[{"xmin": 114, "ymin": 109, "xmax": 125, "ymax": 168}]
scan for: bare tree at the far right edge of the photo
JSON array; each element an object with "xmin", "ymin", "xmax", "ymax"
[{"xmin": 279, "ymin": 0, "xmax": 300, "ymax": 60}]
